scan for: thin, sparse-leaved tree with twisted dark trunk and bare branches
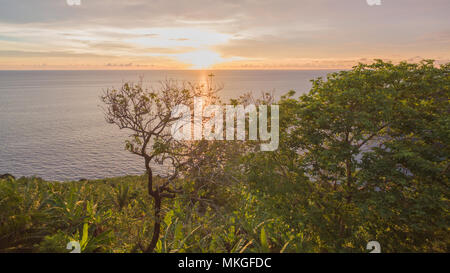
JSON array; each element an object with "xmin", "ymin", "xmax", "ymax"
[{"xmin": 101, "ymin": 79, "xmax": 220, "ymax": 252}]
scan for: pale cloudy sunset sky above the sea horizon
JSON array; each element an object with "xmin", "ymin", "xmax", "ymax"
[{"xmin": 0, "ymin": 0, "xmax": 450, "ymax": 70}]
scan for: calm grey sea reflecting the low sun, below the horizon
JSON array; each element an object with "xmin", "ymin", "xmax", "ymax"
[{"xmin": 0, "ymin": 71, "xmax": 331, "ymax": 181}]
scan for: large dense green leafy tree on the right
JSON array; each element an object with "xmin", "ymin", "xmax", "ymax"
[{"xmin": 246, "ymin": 61, "xmax": 450, "ymax": 252}]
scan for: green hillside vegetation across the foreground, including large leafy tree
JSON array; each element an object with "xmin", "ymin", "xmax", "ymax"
[{"xmin": 0, "ymin": 61, "xmax": 450, "ymax": 253}]
